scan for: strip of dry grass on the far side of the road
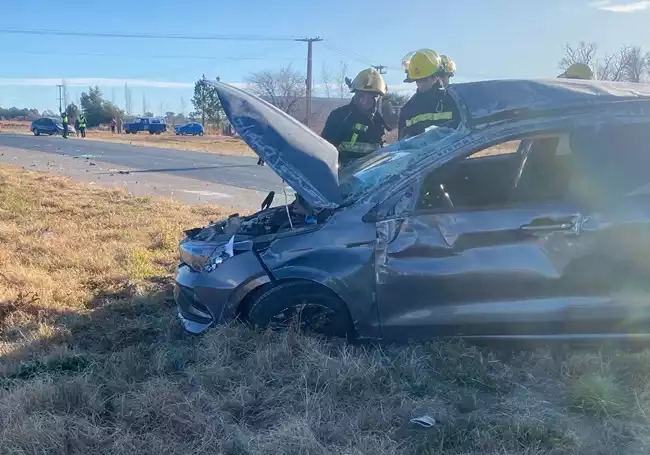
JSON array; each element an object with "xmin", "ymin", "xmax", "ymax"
[{"xmin": 0, "ymin": 120, "xmax": 257, "ymax": 156}]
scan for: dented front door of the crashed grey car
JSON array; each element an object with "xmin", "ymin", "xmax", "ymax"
[{"xmin": 376, "ymin": 130, "xmax": 586, "ymax": 339}]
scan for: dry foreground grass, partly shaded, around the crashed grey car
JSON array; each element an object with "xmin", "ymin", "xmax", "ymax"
[{"xmin": 0, "ymin": 167, "xmax": 650, "ymax": 455}]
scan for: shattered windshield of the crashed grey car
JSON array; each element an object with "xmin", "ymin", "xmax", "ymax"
[{"xmin": 339, "ymin": 127, "xmax": 460, "ymax": 205}]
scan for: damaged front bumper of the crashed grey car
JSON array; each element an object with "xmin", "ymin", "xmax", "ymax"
[{"xmin": 174, "ymin": 251, "xmax": 271, "ymax": 334}]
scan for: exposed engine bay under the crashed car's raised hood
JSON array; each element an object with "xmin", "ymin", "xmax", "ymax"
[{"xmin": 185, "ymin": 191, "xmax": 332, "ymax": 242}]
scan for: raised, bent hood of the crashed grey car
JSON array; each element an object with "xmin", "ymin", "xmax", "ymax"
[{"xmin": 205, "ymin": 80, "xmax": 341, "ymax": 209}]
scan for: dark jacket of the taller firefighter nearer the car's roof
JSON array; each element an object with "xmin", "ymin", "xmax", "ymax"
[{"xmin": 397, "ymin": 85, "xmax": 460, "ymax": 139}]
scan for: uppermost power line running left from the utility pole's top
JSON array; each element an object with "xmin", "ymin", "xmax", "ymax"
[{"xmin": 0, "ymin": 28, "xmax": 296, "ymax": 41}]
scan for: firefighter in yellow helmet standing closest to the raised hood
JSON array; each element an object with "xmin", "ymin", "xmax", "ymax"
[{"xmin": 321, "ymin": 68, "xmax": 390, "ymax": 167}]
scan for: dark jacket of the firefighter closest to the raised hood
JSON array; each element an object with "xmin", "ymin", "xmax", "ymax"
[{"xmin": 321, "ymin": 103, "xmax": 389, "ymax": 167}]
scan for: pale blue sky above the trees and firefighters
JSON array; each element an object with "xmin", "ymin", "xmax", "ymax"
[{"xmin": 0, "ymin": 0, "xmax": 650, "ymax": 114}]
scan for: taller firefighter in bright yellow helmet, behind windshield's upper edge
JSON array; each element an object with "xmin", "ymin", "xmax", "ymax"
[{"xmin": 397, "ymin": 49, "xmax": 460, "ymax": 139}]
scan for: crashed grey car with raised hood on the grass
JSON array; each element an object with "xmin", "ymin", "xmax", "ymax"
[{"xmin": 175, "ymin": 79, "xmax": 650, "ymax": 340}]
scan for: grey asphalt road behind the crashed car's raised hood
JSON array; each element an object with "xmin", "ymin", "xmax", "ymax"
[{"xmin": 0, "ymin": 133, "xmax": 283, "ymax": 192}]
